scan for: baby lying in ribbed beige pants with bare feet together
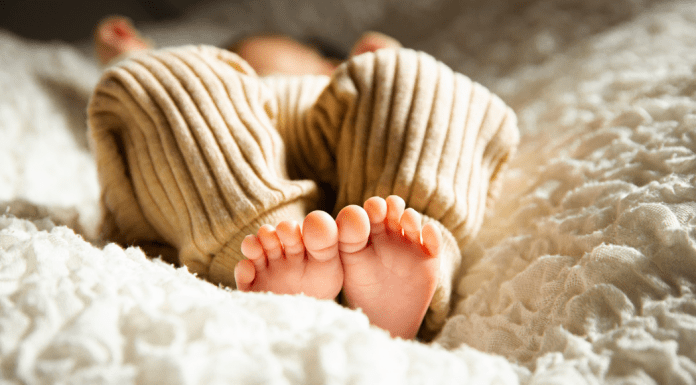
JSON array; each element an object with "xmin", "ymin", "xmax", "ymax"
[{"xmin": 88, "ymin": 18, "xmax": 518, "ymax": 339}]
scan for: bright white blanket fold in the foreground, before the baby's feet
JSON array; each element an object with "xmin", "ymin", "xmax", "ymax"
[{"xmin": 0, "ymin": 214, "xmax": 515, "ymax": 384}]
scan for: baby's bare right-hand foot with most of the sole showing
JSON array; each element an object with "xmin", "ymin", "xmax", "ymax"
[{"xmin": 336, "ymin": 196, "xmax": 442, "ymax": 339}]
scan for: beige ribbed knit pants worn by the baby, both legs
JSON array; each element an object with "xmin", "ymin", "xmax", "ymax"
[{"xmin": 88, "ymin": 46, "xmax": 519, "ymax": 330}]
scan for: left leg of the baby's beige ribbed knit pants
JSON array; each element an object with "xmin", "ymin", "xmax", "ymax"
[{"xmin": 88, "ymin": 47, "xmax": 316, "ymax": 287}]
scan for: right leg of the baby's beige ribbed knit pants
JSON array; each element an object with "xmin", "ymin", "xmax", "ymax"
[{"xmin": 285, "ymin": 49, "xmax": 519, "ymax": 330}]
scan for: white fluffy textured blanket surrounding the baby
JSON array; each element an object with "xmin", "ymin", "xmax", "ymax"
[{"xmin": 0, "ymin": 0, "xmax": 696, "ymax": 384}]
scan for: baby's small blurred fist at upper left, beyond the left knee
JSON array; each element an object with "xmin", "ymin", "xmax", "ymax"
[{"xmin": 94, "ymin": 16, "xmax": 151, "ymax": 65}]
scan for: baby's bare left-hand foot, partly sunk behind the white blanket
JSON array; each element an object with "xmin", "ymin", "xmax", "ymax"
[{"xmin": 234, "ymin": 211, "xmax": 343, "ymax": 299}]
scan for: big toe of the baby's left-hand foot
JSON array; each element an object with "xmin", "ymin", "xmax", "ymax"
[{"xmin": 302, "ymin": 210, "xmax": 338, "ymax": 261}]
